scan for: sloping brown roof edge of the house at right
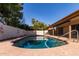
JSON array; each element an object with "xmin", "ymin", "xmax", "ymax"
[{"xmin": 48, "ymin": 10, "xmax": 79, "ymax": 28}]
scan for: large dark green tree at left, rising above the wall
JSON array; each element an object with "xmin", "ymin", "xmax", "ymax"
[{"xmin": 0, "ymin": 3, "xmax": 23, "ymax": 27}]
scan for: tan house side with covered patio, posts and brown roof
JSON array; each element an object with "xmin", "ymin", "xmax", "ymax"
[{"xmin": 48, "ymin": 10, "xmax": 79, "ymax": 40}]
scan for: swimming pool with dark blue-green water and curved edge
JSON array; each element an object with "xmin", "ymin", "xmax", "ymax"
[{"xmin": 13, "ymin": 36, "xmax": 66, "ymax": 49}]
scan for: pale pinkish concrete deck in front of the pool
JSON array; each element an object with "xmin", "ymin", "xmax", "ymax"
[{"xmin": 0, "ymin": 35, "xmax": 79, "ymax": 56}]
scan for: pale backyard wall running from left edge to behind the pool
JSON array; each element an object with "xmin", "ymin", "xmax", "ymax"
[{"xmin": 0, "ymin": 23, "xmax": 47, "ymax": 40}]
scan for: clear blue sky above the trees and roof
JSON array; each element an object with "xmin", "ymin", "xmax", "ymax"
[{"xmin": 23, "ymin": 3, "xmax": 79, "ymax": 25}]
